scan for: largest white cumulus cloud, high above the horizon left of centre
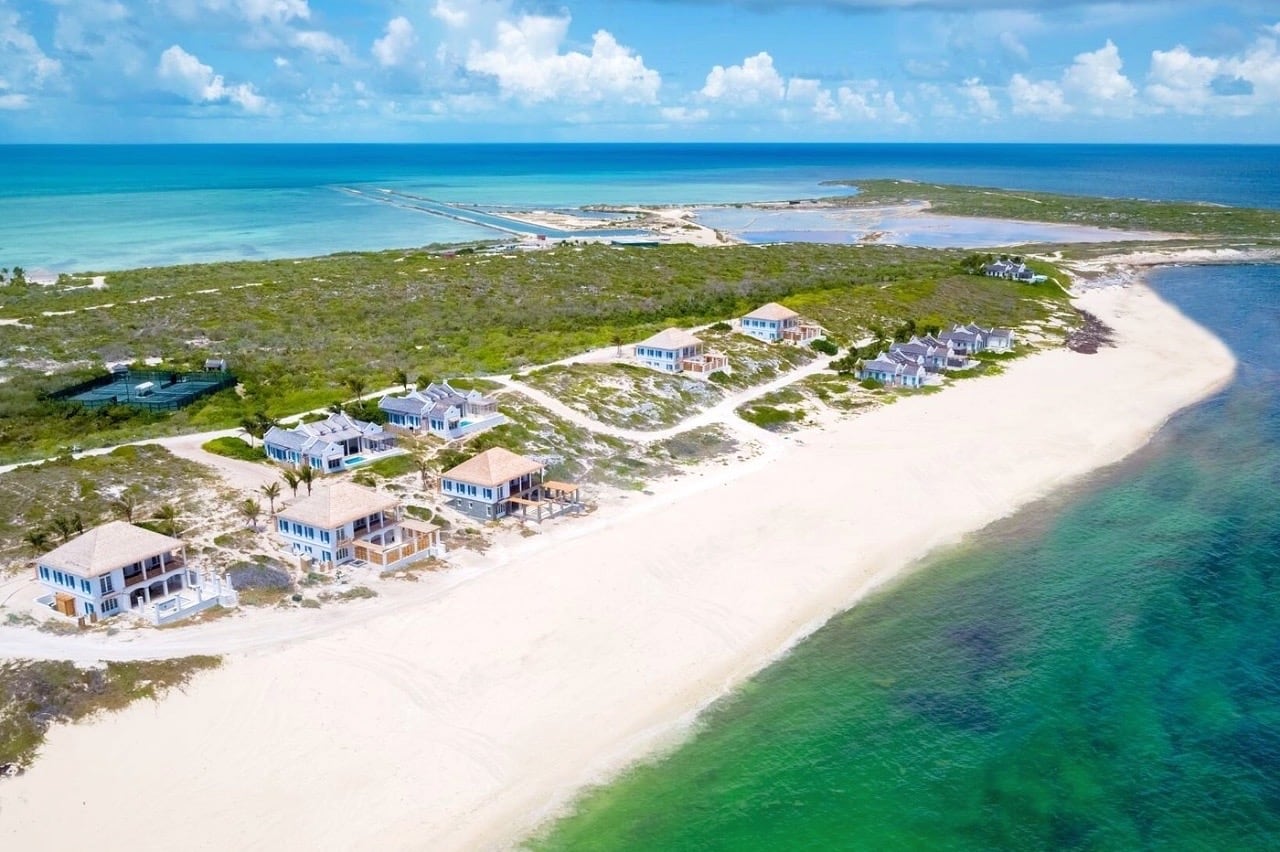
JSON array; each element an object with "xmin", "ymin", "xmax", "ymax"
[{"xmin": 466, "ymin": 15, "xmax": 662, "ymax": 104}]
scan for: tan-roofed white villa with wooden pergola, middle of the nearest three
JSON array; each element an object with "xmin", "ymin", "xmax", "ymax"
[{"xmin": 275, "ymin": 482, "xmax": 444, "ymax": 571}]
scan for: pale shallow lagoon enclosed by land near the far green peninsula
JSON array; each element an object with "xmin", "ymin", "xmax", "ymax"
[{"xmin": 696, "ymin": 206, "xmax": 1170, "ymax": 248}]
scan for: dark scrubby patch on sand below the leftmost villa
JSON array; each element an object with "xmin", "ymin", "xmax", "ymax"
[{"xmin": 0, "ymin": 656, "xmax": 221, "ymax": 775}]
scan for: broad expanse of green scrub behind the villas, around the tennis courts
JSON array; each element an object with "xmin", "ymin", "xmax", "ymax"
[{"xmin": 0, "ymin": 244, "xmax": 1062, "ymax": 463}]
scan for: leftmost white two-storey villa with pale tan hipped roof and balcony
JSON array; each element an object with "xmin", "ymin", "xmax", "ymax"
[{"xmin": 36, "ymin": 521, "xmax": 196, "ymax": 620}]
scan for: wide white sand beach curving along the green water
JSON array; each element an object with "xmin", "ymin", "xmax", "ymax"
[{"xmin": 0, "ymin": 277, "xmax": 1234, "ymax": 852}]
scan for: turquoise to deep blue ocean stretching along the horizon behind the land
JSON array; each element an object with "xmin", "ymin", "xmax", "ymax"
[{"xmin": 0, "ymin": 145, "xmax": 1280, "ymax": 271}]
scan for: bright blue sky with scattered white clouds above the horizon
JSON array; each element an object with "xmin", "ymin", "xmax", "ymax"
[{"xmin": 0, "ymin": 0, "xmax": 1280, "ymax": 143}]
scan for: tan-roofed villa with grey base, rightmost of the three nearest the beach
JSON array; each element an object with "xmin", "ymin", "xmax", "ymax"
[{"xmin": 440, "ymin": 446, "xmax": 580, "ymax": 521}]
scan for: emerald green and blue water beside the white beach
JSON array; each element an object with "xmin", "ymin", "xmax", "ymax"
[{"xmin": 531, "ymin": 266, "xmax": 1280, "ymax": 851}]
